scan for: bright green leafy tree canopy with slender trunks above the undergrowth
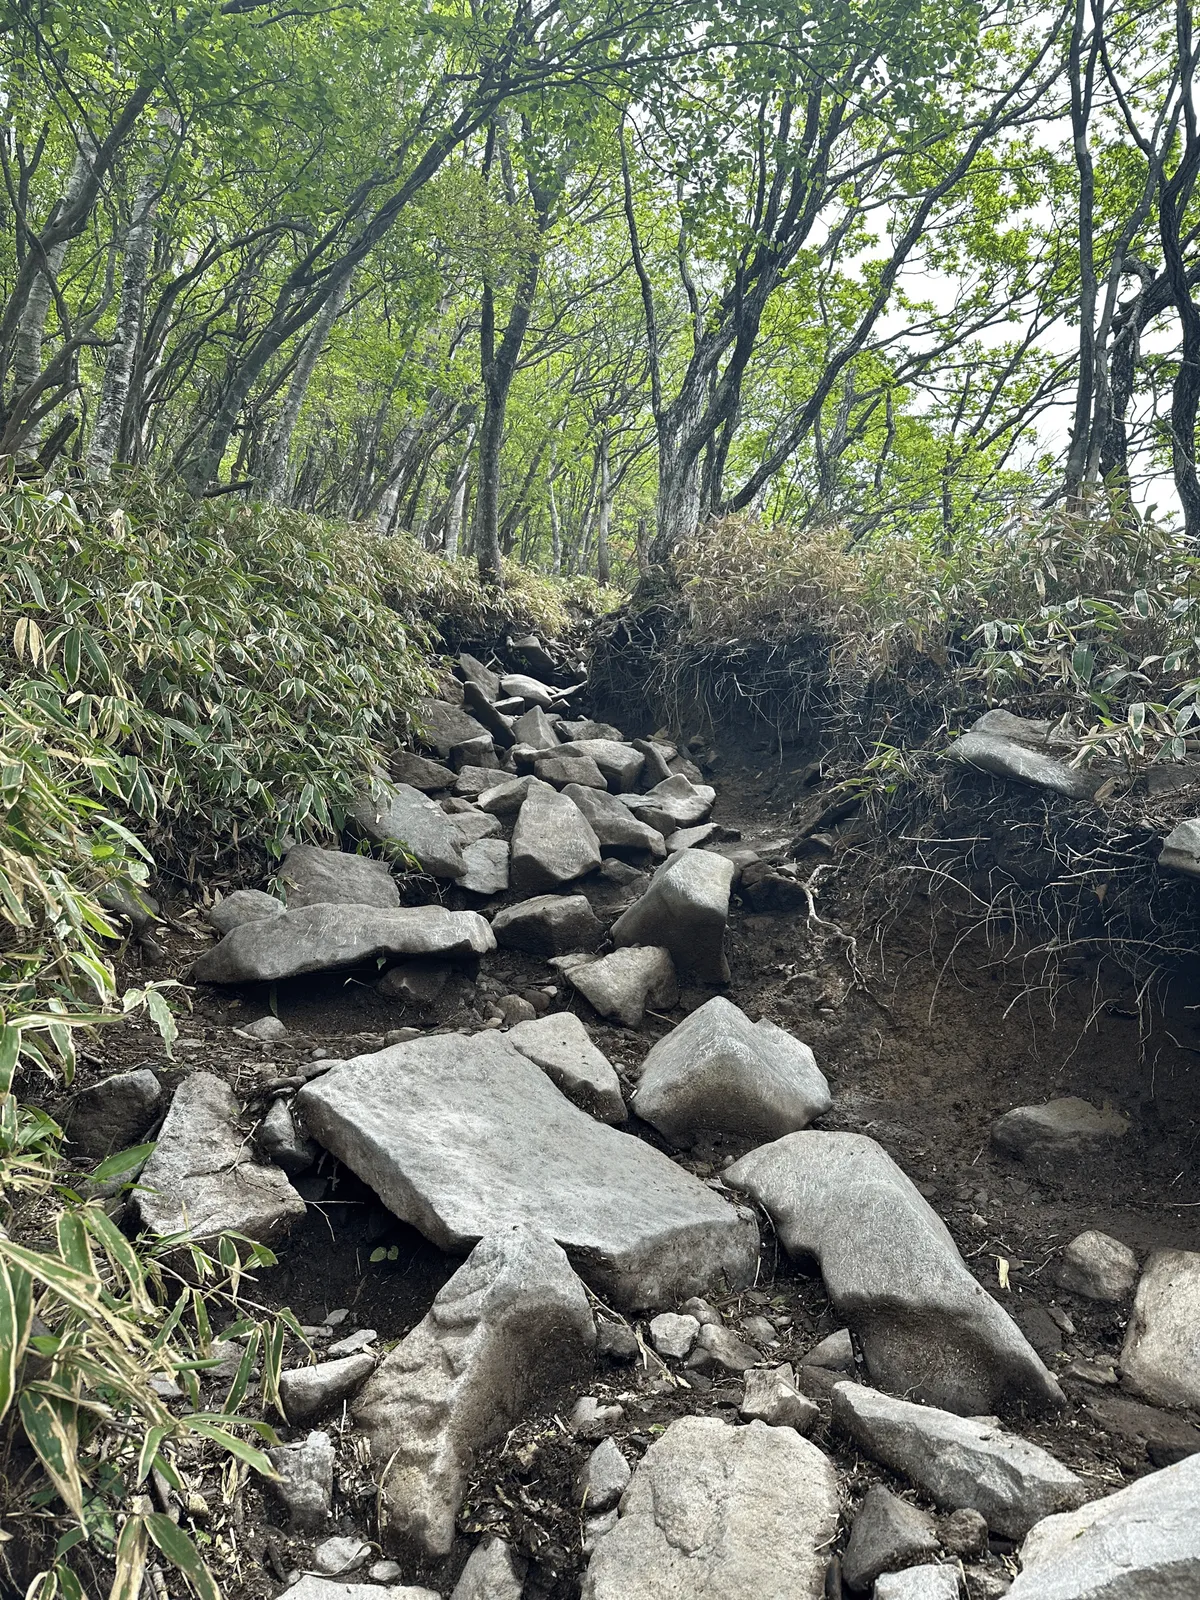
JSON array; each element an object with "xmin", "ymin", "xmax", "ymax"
[{"xmin": 0, "ymin": 0, "xmax": 1200, "ymax": 582}]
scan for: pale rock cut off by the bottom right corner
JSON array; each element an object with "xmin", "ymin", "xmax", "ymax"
[{"xmin": 1008, "ymin": 1456, "xmax": 1200, "ymax": 1600}]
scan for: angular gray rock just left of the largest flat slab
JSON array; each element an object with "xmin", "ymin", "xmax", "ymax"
[{"xmin": 134, "ymin": 1072, "xmax": 306, "ymax": 1245}]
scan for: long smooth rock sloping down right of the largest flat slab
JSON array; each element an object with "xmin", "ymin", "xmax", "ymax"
[{"xmin": 723, "ymin": 1131, "xmax": 1062, "ymax": 1416}]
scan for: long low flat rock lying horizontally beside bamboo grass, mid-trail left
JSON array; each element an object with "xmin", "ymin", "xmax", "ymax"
[{"xmin": 192, "ymin": 906, "xmax": 496, "ymax": 984}]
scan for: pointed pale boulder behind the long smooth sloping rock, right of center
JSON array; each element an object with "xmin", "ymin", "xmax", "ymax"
[{"xmin": 634, "ymin": 995, "xmax": 832, "ymax": 1146}]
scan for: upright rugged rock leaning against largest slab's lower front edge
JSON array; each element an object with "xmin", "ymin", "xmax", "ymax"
[{"xmin": 354, "ymin": 1226, "xmax": 595, "ymax": 1557}]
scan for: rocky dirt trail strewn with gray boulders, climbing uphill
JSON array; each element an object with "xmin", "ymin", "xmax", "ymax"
[{"xmin": 61, "ymin": 640, "xmax": 1200, "ymax": 1600}]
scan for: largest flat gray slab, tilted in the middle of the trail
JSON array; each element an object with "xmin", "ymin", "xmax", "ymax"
[{"xmin": 296, "ymin": 1032, "xmax": 758, "ymax": 1309}]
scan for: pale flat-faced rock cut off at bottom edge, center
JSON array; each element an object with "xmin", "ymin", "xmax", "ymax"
[{"xmin": 582, "ymin": 1416, "xmax": 838, "ymax": 1600}]
